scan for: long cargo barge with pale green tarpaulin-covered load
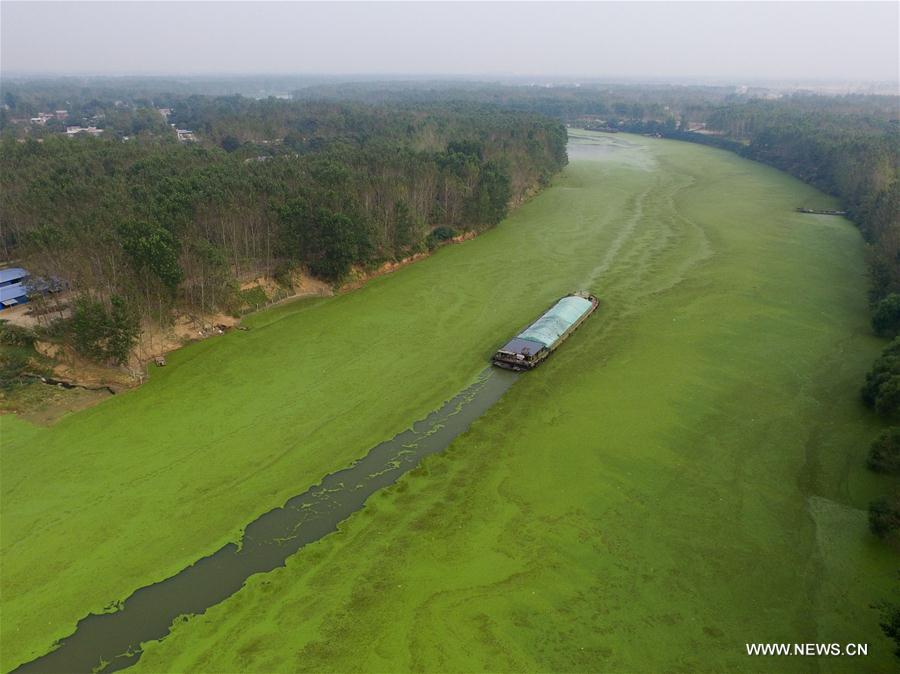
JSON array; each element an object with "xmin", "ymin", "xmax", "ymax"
[{"xmin": 491, "ymin": 291, "xmax": 600, "ymax": 372}]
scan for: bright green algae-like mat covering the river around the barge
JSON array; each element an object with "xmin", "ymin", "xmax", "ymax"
[{"xmin": 0, "ymin": 131, "xmax": 896, "ymax": 672}]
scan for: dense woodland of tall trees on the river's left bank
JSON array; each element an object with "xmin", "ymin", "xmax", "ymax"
[{"xmin": 0, "ymin": 97, "xmax": 567, "ymax": 330}]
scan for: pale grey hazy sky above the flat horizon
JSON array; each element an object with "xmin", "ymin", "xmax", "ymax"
[{"xmin": 0, "ymin": 0, "xmax": 900, "ymax": 82}]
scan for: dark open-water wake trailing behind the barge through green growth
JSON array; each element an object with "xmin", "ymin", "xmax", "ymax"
[{"xmin": 14, "ymin": 369, "xmax": 518, "ymax": 674}]
